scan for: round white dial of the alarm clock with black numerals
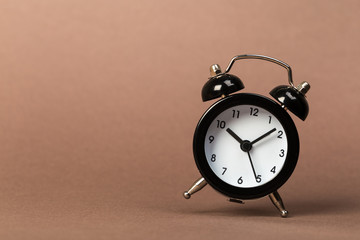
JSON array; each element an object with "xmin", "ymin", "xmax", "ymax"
[{"xmin": 204, "ymin": 105, "xmax": 288, "ymax": 188}]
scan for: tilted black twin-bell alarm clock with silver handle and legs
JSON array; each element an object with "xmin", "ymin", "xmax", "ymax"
[{"xmin": 184, "ymin": 55, "xmax": 310, "ymax": 217}]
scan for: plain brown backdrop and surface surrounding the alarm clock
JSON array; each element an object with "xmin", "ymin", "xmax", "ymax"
[{"xmin": 0, "ymin": 0, "xmax": 360, "ymax": 239}]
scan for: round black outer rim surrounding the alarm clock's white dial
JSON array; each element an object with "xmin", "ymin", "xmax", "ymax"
[{"xmin": 193, "ymin": 93, "xmax": 299, "ymax": 199}]
